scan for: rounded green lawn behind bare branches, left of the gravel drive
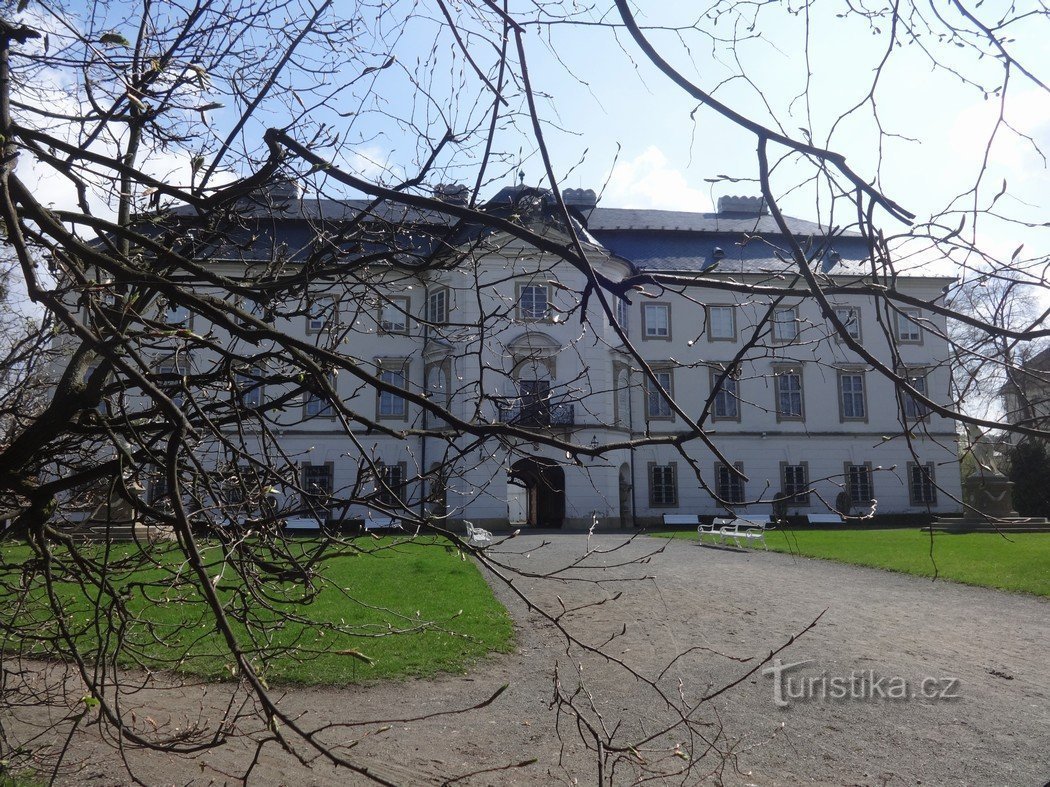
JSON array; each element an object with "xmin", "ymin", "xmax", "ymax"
[{"xmin": 0, "ymin": 538, "xmax": 513, "ymax": 684}]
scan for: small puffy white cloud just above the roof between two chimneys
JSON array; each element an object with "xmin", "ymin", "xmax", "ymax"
[{"xmin": 602, "ymin": 145, "xmax": 712, "ymax": 212}]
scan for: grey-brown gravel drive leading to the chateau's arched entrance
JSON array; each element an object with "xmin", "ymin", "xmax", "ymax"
[{"xmin": 3, "ymin": 534, "xmax": 1050, "ymax": 786}]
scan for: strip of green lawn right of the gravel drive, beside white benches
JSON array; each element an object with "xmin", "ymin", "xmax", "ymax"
[{"xmin": 662, "ymin": 529, "xmax": 1050, "ymax": 596}]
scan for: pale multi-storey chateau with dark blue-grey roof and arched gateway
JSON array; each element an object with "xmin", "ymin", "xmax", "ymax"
[{"xmin": 137, "ymin": 187, "xmax": 960, "ymax": 529}]
